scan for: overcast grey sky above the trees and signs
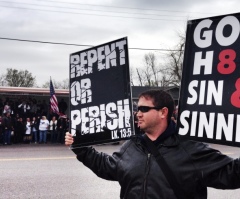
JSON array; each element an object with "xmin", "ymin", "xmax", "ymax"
[{"xmin": 0, "ymin": 0, "xmax": 240, "ymax": 86}]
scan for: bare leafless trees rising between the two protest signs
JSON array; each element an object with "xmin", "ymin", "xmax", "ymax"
[{"xmin": 132, "ymin": 32, "xmax": 185, "ymax": 87}]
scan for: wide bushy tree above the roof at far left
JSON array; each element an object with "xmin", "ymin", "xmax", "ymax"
[{"xmin": 5, "ymin": 68, "xmax": 36, "ymax": 87}]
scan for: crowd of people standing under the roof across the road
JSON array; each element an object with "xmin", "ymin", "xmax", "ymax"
[{"xmin": 0, "ymin": 97, "xmax": 69, "ymax": 145}]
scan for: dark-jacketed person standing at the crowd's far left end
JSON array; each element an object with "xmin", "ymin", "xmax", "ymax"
[{"xmin": 2, "ymin": 111, "xmax": 13, "ymax": 145}]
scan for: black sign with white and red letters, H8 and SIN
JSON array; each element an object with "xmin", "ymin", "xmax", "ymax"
[{"xmin": 178, "ymin": 13, "xmax": 240, "ymax": 146}]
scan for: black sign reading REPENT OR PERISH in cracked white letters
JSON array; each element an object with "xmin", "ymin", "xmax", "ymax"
[{"xmin": 70, "ymin": 38, "xmax": 133, "ymax": 147}]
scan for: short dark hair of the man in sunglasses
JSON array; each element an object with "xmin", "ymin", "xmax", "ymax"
[{"xmin": 138, "ymin": 89, "xmax": 174, "ymax": 121}]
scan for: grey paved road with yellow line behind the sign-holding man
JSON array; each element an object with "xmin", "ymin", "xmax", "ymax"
[{"xmin": 0, "ymin": 142, "xmax": 240, "ymax": 199}]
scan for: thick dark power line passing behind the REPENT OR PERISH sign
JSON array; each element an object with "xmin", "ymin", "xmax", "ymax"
[{"xmin": 0, "ymin": 37, "xmax": 181, "ymax": 52}]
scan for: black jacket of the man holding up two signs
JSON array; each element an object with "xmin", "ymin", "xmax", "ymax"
[{"xmin": 73, "ymin": 122, "xmax": 240, "ymax": 199}]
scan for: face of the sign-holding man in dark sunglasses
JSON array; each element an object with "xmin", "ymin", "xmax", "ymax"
[{"xmin": 137, "ymin": 97, "xmax": 161, "ymax": 133}]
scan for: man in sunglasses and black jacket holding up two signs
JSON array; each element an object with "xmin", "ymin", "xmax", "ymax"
[{"xmin": 65, "ymin": 90, "xmax": 240, "ymax": 199}]
